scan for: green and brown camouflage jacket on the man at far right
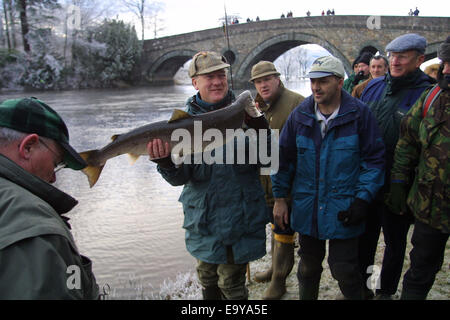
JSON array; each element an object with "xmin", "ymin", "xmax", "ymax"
[{"xmin": 391, "ymin": 89, "xmax": 450, "ymax": 233}]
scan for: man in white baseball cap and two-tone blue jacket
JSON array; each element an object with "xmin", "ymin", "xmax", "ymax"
[{"xmin": 271, "ymin": 56, "xmax": 384, "ymax": 300}]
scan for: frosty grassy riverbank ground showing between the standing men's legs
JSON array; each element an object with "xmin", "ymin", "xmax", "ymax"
[{"xmin": 149, "ymin": 228, "xmax": 450, "ymax": 300}]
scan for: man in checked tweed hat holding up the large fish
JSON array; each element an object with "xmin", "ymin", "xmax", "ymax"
[{"xmin": 147, "ymin": 51, "xmax": 271, "ymax": 300}]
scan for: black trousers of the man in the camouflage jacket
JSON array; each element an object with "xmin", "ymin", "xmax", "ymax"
[{"xmin": 401, "ymin": 221, "xmax": 449, "ymax": 300}]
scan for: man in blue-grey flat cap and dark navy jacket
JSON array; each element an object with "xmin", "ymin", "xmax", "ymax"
[{"xmin": 359, "ymin": 33, "xmax": 435, "ymax": 299}]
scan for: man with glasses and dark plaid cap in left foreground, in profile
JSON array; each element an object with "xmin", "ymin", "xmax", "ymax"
[{"xmin": 0, "ymin": 98, "xmax": 99, "ymax": 300}]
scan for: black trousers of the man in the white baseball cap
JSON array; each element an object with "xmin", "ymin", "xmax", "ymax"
[{"xmin": 297, "ymin": 235, "xmax": 363, "ymax": 300}]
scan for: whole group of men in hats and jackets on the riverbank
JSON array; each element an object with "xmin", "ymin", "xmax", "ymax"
[{"xmin": 0, "ymin": 33, "xmax": 450, "ymax": 300}]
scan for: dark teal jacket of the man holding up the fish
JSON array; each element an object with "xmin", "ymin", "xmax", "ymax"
[{"xmin": 158, "ymin": 92, "xmax": 270, "ymax": 264}]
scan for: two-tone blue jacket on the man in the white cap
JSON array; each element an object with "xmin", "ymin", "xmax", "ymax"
[{"xmin": 272, "ymin": 90, "xmax": 384, "ymax": 239}]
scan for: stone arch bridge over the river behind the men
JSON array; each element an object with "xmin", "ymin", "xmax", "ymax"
[{"xmin": 135, "ymin": 16, "xmax": 450, "ymax": 88}]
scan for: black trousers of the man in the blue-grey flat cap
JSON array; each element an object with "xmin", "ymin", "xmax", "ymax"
[{"xmin": 358, "ymin": 200, "xmax": 414, "ymax": 295}]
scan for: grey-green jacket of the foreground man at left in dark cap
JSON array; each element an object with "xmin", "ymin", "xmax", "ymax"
[{"xmin": 0, "ymin": 155, "xmax": 99, "ymax": 300}]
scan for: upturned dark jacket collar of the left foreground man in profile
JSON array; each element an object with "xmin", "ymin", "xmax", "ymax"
[{"xmin": 0, "ymin": 154, "xmax": 78, "ymax": 215}]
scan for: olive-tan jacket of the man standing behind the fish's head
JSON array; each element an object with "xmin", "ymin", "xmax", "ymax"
[{"xmin": 255, "ymin": 82, "xmax": 305, "ymax": 207}]
